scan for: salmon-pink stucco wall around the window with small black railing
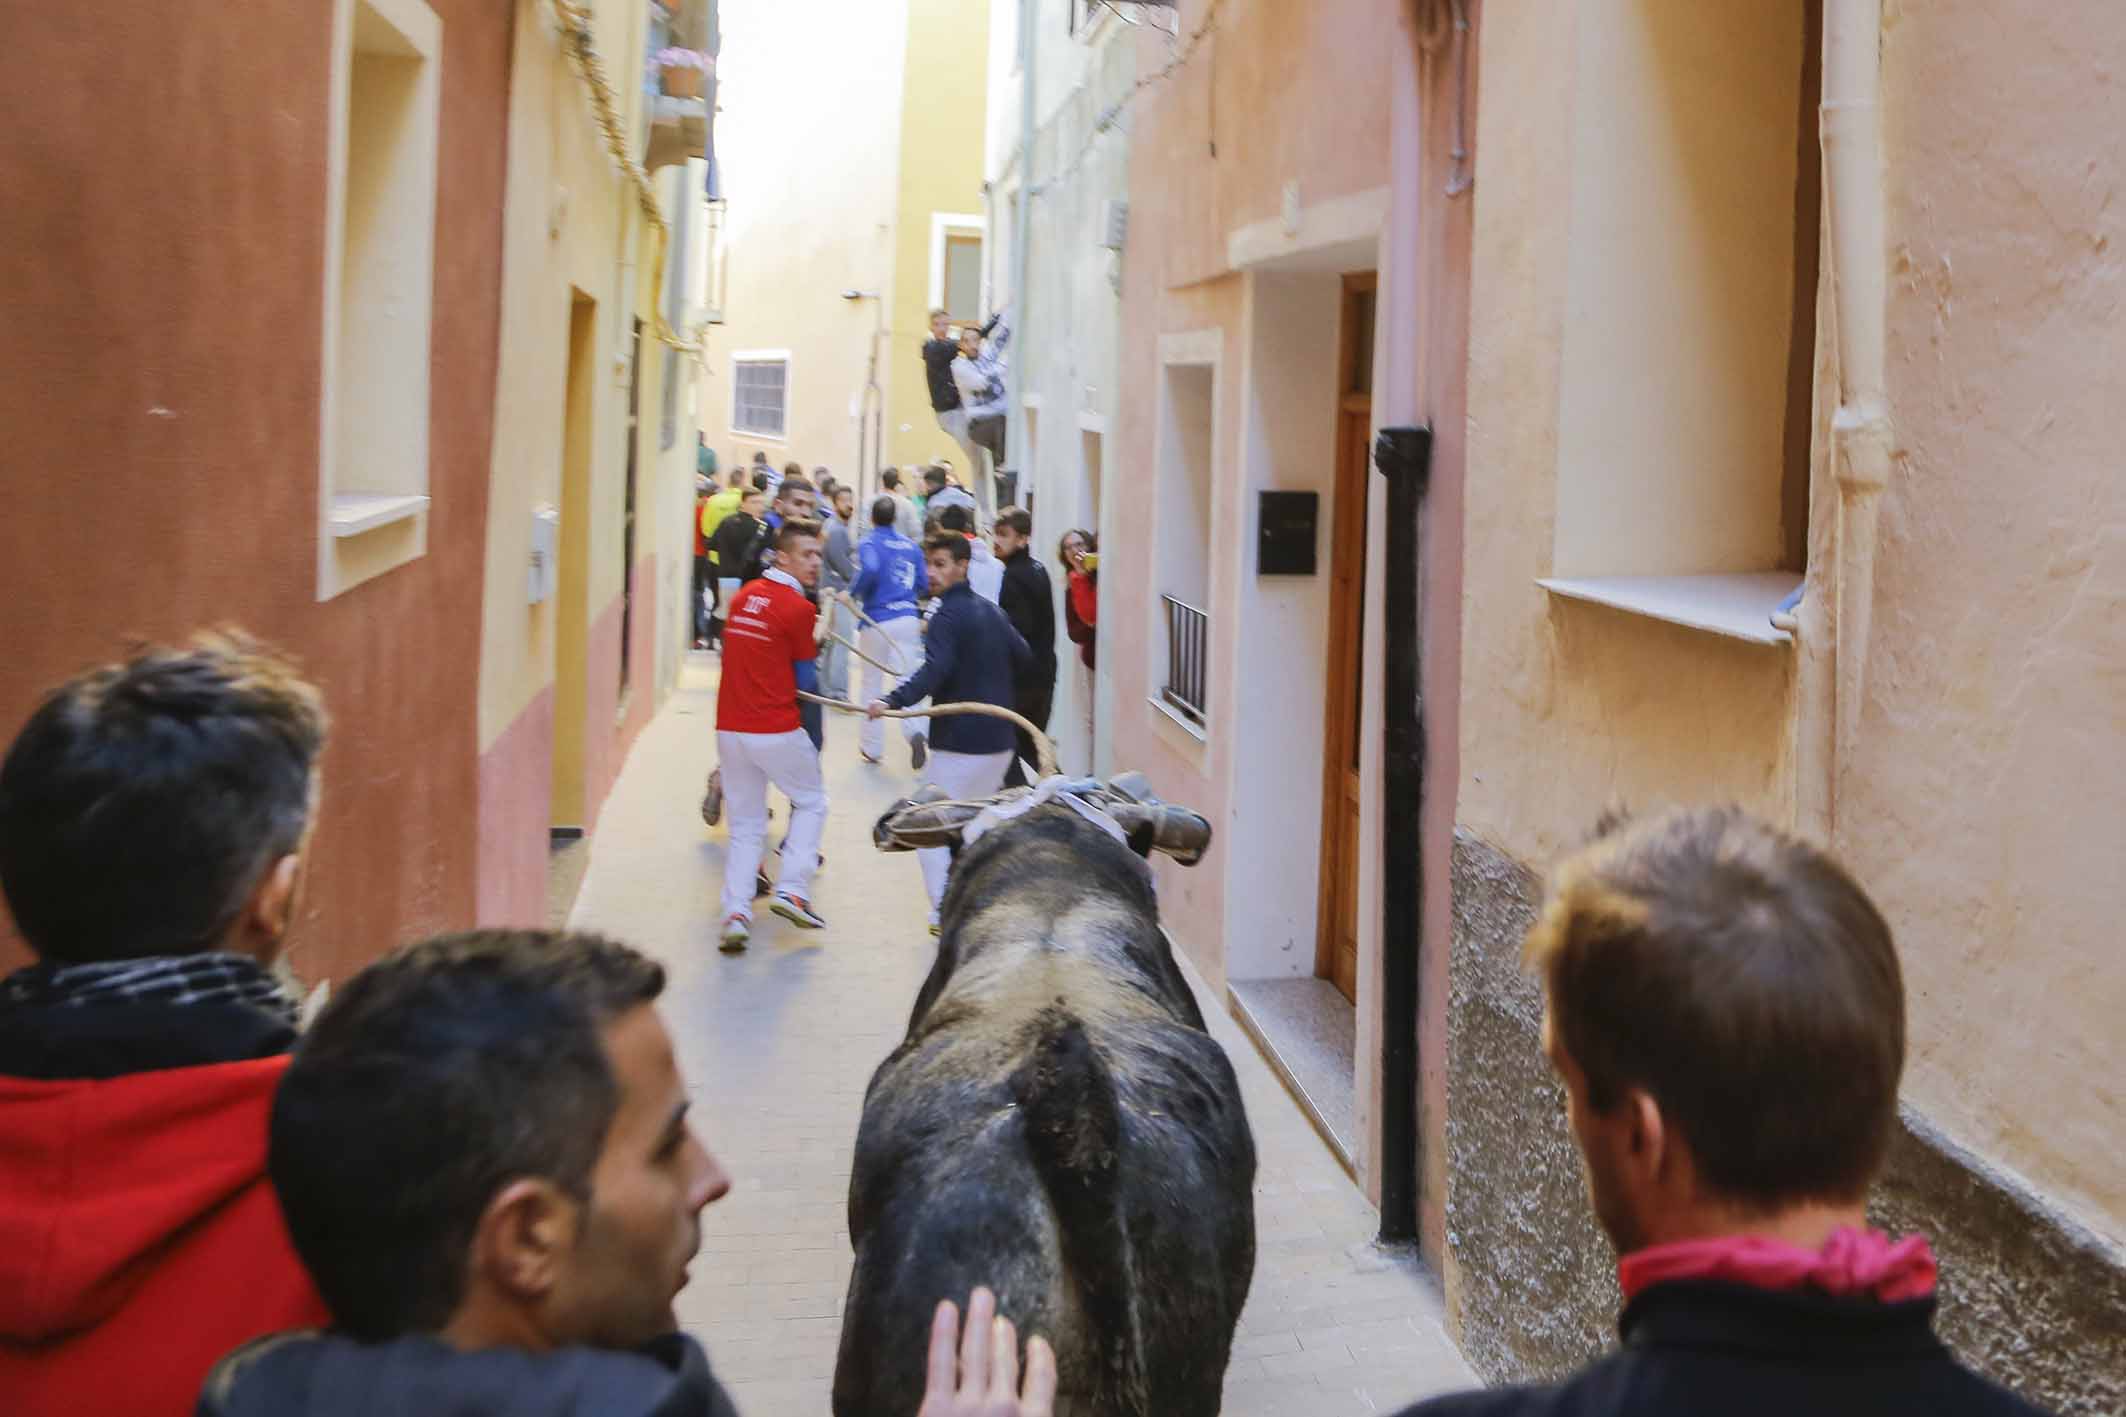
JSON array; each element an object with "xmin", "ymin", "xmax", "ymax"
[{"xmin": 1101, "ymin": 0, "xmax": 1399, "ymax": 986}]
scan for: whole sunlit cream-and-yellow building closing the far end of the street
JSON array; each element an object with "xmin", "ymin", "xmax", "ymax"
[{"xmin": 702, "ymin": 0, "xmax": 993, "ymax": 491}]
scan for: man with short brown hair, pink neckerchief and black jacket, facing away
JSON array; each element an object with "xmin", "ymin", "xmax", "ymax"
[{"xmin": 1412, "ymin": 807, "xmax": 2037, "ymax": 1417}]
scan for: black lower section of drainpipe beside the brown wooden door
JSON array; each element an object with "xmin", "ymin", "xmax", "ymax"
[{"xmin": 1373, "ymin": 427, "xmax": 1433, "ymax": 1245}]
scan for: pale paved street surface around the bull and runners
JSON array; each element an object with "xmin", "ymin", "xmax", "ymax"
[{"xmin": 572, "ymin": 654, "xmax": 1473, "ymax": 1417}]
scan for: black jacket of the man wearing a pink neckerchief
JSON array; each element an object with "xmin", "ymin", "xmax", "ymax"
[{"xmin": 1405, "ymin": 1279, "xmax": 2039, "ymax": 1417}]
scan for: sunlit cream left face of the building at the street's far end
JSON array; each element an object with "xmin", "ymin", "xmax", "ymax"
[{"xmin": 702, "ymin": 0, "xmax": 901, "ymax": 476}]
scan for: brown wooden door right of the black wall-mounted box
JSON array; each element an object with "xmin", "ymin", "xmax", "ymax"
[{"xmin": 1314, "ymin": 272, "xmax": 1380, "ymax": 1005}]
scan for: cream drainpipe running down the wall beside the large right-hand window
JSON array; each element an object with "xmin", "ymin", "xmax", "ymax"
[{"xmin": 1801, "ymin": 0, "xmax": 1896, "ymax": 841}]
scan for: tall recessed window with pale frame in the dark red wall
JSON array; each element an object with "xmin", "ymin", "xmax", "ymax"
[{"xmin": 317, "ymin": 0, "xmax": 442, "ymax": 599}]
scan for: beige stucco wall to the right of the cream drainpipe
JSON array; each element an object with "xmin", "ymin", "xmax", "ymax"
[{"xmin": 1837, "ymin": 0, "xmax": 2126, "ymax": 1241}]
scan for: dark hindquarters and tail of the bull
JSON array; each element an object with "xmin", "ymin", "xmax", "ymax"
[{"xmin": 836, "ymin": 994, "xmax": 1254, "ymax": 1417}]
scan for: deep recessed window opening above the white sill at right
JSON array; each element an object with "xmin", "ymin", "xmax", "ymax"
[{"xmin": 1552, "ymin": 0, "xmax": 1820, "ymax": 633}]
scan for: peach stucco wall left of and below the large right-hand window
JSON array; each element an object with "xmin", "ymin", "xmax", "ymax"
[{"xmin": 1458, "ymin": 6, "xmax": 1799, "ymax": 879}]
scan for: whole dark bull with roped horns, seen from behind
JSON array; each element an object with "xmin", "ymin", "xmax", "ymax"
[{"xmin": 833, "ymin": 780, "xmax": 1254, "ymax": 1417}]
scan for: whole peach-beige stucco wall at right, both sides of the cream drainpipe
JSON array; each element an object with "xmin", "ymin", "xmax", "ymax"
[{"xmin": 1458, "ymin": 0, "xmax": 2126, "ymax": 1243}]
